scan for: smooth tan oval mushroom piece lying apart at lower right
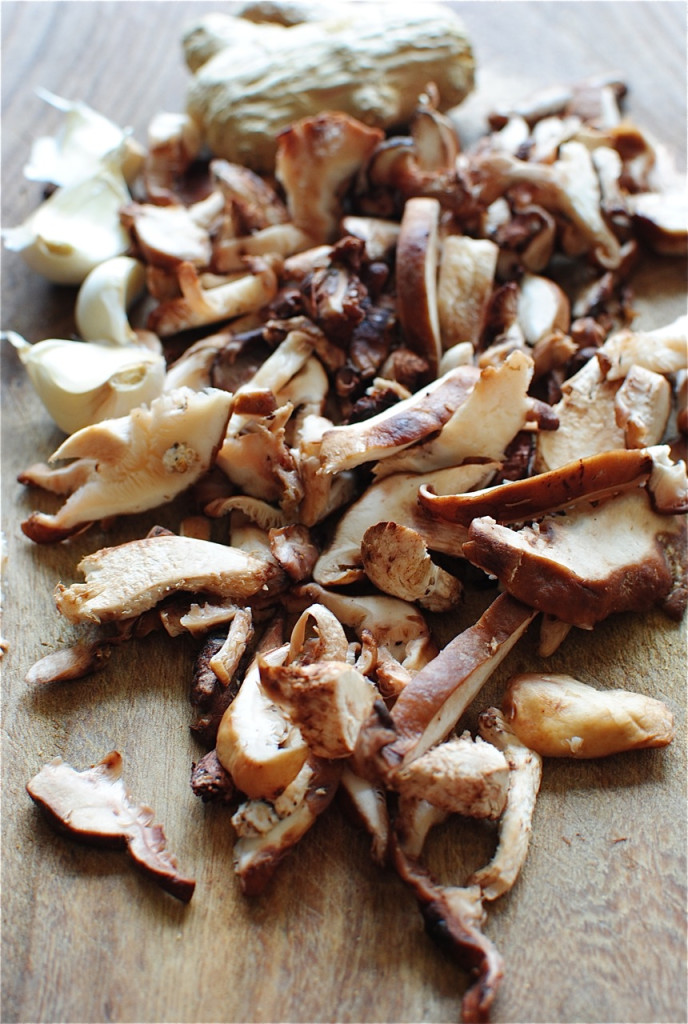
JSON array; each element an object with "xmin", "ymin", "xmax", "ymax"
[{"xmin": 502, "ymin": 673, "xmax": 675, "ymax": 758}]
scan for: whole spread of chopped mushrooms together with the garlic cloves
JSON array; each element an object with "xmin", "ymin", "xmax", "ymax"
[{"xmin": 4, "ymin": 32, "xmax": 688, "ymax": 1021}]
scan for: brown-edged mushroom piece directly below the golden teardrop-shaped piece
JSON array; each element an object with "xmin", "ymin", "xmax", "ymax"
[{"xmin": 232, "ymin": 757, "xmax": 344, "ymax": 896}]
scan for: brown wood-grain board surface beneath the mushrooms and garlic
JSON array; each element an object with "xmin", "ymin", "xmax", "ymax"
[{"xmin": 1, "ymin": 0, "xmax": 687, "ymax": 1024}]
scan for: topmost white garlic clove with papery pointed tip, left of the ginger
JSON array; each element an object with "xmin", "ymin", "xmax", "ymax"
[{"xmin": 24, "ymin": 88, "xmax": 144, "ymax": 187}]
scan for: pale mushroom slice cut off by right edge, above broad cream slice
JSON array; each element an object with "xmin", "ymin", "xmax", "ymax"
[{"xmin": 596, "ymin": 315, "xmax": 688, "ymax": 381}]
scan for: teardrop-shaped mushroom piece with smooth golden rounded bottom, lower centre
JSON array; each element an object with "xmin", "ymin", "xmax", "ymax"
[{"xmin": 215, "ymin": 644, "xmax": 308, "ymax": 801}]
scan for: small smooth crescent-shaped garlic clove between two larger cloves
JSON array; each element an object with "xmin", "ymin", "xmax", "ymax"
[{"xmin": 75, "ymin": 256, "xmax": 145, "ymax": 345}]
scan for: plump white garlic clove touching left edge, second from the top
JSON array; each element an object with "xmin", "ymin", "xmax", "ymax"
[{"xmin": 3, "ymin": 168, "xmax": 130, "ymax": 285}]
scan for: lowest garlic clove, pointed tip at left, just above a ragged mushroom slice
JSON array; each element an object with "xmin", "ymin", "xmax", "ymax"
[{"xmin": 2, "ymin": 331, "xmax": 165, "ymax": 434}]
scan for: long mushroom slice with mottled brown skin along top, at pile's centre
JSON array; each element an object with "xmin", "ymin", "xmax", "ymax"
[{"xmin": 319, "ymin": 366, "xmax": 480, "ymax": 473}]
